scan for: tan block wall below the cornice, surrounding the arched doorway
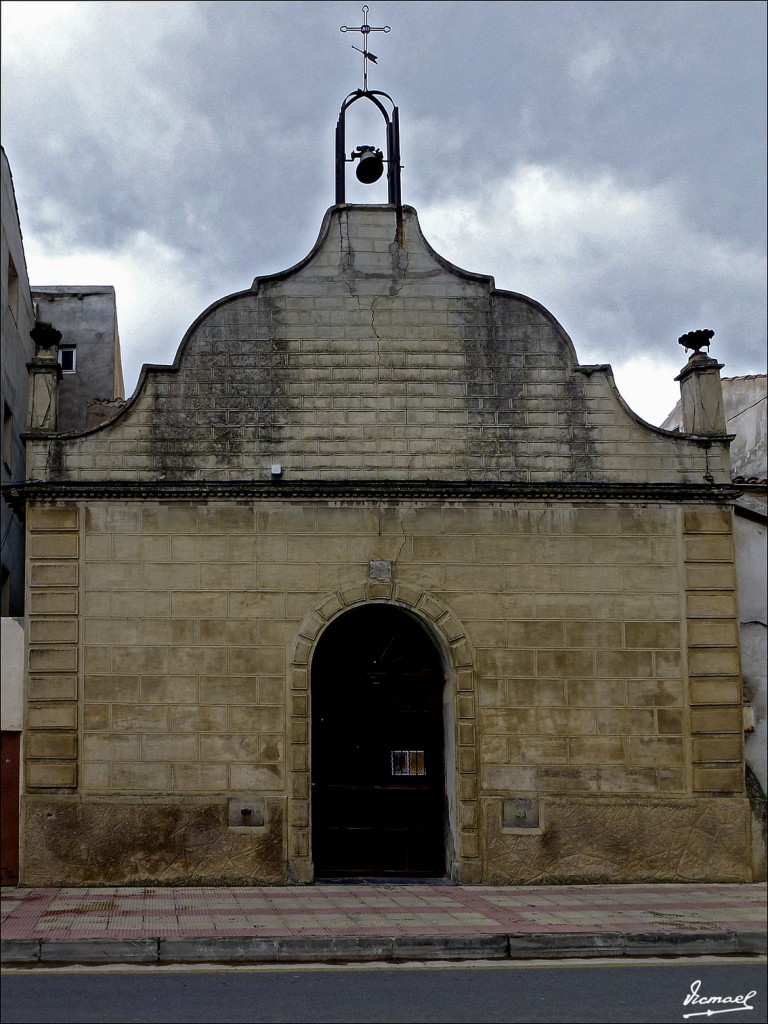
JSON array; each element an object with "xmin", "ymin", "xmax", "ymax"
[{"xmin": 24, "ymin": 500, "xmax": 749, "ymax": 885}]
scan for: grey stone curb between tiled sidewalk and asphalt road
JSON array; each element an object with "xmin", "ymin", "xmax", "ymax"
[{"xmin": 0, "ymin": 931, "xmax": 768, "ymax": 966}]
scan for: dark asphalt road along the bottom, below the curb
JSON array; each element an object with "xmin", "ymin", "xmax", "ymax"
[{"xmin": 0, "ymin": 957, "xmax": 768, "ymax": 1024}]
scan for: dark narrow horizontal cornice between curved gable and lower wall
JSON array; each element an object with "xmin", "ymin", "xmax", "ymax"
[{"xmin": 2, "ymin": 480, "xmax": 742, "ymax": 506}]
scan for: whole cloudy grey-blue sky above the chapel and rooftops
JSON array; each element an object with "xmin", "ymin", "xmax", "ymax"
[{"xmin": 2, "ymin": 0, "xmax": 766, "ymax": 423}]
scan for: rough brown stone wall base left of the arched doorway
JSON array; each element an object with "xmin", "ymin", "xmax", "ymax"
[{"xmin": 22, "ymin": 796, "xmax": 287, "ymax": 886}]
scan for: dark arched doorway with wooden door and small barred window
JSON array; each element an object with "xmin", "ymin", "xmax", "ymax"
[{"xmin": 311, "ymin": 604, "xmax": 445, "ymax": 878}]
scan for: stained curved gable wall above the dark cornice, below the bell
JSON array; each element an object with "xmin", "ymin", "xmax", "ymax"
[{"xmin": 30, "ymin": 207, "xmax": 730, "ymax": 483}]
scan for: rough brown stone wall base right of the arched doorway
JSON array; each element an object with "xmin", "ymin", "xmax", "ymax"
[{"xmin": 482, "ymin": 797, "xmax": 753, "ymax": 885}]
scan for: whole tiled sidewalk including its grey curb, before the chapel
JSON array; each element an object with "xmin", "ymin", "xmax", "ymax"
[{"xmin": 2, "ymin": 883, "xmax": 766, "ymax": 965}]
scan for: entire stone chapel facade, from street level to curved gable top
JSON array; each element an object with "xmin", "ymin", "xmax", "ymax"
[{"xmin": 16, "ymin": 197, "xmax": 752, "ymax": 885}]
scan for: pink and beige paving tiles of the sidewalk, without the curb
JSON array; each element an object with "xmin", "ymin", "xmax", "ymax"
[{"xmin": 2, "ymin": 885, "xmax": 766, "ymax": 938}]
